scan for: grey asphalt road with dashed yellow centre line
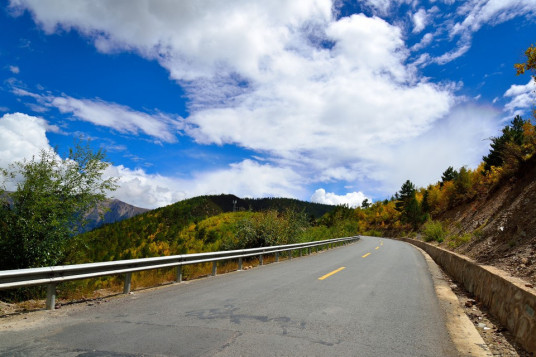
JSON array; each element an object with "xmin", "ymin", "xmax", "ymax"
[{"xmin": 0, "ymin": 237, "xmax": 457, "ymax": 357}]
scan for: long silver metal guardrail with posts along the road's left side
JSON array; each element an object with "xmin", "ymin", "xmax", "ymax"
[{"xmin": 0, "ymin": 236, "xmax": 359, "ymax": 310}]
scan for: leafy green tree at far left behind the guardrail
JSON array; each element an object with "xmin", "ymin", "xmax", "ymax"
[{"xmin": 0, "ymin": 141, "xmax": 116, "ymax": 269}]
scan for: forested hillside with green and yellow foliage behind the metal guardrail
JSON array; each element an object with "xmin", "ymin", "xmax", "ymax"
[{"xmin": 65, "ymin": 195, "xmax": 340, "ymax": 263}]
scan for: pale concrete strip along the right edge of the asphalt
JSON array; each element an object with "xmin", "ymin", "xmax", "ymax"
[{"xmin": 404, "ymin": 242, "xmax": 493, "ymax": 357}]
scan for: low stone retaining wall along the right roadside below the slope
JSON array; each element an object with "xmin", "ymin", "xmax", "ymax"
[{"xmin": 401, "ymin": 238, "xmax": 536, "ymax": 356}]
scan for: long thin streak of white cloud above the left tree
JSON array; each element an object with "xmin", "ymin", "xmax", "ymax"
[{"xmin": 13, "ymin": 88, "xmax": 182, "ymax": 142}]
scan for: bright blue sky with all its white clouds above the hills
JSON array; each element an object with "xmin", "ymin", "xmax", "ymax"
[{"xmin": 0, "ymin": 0, "xmax": 536, "ymax": 208}]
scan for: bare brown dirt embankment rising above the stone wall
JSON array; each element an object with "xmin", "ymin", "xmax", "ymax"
[{"xmin": 439, "ymin": 160, "xmax": 536, "ymax": 286}]
